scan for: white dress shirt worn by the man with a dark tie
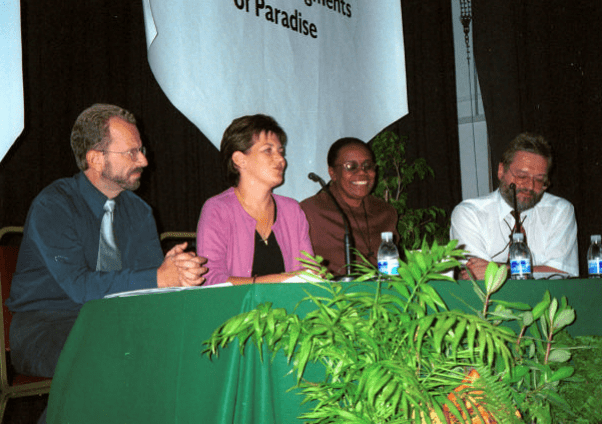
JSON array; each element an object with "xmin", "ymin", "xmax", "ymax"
[{"xmin": 450, "ymin": 189, "xmax": 579, "ymax": 276}]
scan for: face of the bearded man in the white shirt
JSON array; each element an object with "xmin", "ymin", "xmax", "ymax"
[{"xmin": 498, "ymin": 151, "xmax": 548, "ymax": 212}]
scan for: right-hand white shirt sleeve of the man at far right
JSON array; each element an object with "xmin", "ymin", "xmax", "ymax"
[{"xmin": 535, "ymin": 202, "xmax": 579, "ymax": 277}]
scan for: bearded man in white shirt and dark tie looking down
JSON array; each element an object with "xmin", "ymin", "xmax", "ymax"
[{"xmin": 450, "ymin": 133, "xmax": 579, "ymax": 280}]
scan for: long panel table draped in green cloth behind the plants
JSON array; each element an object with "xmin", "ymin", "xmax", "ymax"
[{"xmin": 48, "ymin": 280, "xmax": 602, "ymax": 424}]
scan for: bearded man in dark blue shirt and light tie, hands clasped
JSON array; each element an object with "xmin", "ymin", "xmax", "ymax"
[{"xmin": 6, "ymin": 104, "xmax": 206, "ymax": 402}]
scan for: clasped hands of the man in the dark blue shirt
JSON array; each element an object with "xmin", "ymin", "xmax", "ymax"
[{"xmin": 157, "ymin": 243, "xmax": 207, "ymax": 287}]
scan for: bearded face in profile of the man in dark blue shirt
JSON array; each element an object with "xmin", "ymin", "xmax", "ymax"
[{"xmin": 102, "ymin": 118, "xmax": 148, "ymax": 191}]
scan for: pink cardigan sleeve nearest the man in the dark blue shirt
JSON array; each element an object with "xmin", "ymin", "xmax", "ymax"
[{"xmin": 196, "ymin": 199, "xmax": 232, "ymax": 286}]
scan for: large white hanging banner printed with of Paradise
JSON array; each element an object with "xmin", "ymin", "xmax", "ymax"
[{"xmin": 144, "ymin": 0, "xmax": 408, "ymax": 200}]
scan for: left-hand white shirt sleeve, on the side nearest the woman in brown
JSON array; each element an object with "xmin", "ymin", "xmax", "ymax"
[{"xmin": 449, "ymin": 203, "xmax": 493, "ymax": 261}]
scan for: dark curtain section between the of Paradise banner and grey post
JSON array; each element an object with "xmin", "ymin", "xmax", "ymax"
[{"xmin": 387, "ymin": 0, "xmax": 462, "ymax": 219}]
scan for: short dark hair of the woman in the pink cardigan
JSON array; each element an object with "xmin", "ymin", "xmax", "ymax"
[{"xmin": 220, "ymin": 114, "xmax": 286, "ymax": 187}]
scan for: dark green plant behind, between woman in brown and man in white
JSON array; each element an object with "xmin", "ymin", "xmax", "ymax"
[{"xmin": 372, "ymin": 131, "xmax": 449, "ymax": 250}]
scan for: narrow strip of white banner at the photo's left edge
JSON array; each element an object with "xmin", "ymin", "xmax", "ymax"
[{"xmin": 0, "ymin": 0, "xmax": 24, "ymax": 160}]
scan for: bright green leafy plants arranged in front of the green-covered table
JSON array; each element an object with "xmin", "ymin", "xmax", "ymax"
[{"xmin": 205, "ymin": 240, "xmax": 584, "ymax": 424}]
